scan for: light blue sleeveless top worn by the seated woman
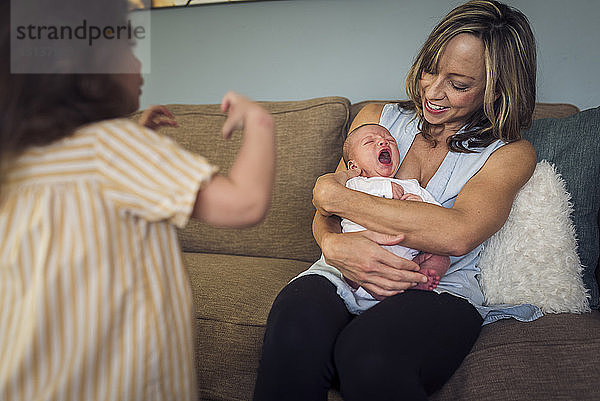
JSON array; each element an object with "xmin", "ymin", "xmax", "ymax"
[{"xmin": 298, "ymin": 104, "xmax": 542, "ymax": 324}]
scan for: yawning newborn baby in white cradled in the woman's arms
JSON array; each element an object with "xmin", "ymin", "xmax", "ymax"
[{"xmin": 342, "ymin": 124, "xmax": 450, "ymax": 299}]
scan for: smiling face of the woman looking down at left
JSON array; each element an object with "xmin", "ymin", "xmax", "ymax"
[{"xmin": 419, "ymin": 33, "xmax": 486, "ymax": 132}]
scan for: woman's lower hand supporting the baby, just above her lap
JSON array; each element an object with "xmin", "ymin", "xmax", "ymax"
[{"xmin": 322, "ymin": 230, "xmax": 427, "ymax": 299}]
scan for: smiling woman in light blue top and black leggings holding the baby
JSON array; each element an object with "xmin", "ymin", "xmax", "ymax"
[{"xmin": 255, "ymin": 0, "xmax": 539, "ymax": 401}]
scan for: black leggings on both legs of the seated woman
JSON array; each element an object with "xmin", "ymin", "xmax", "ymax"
[{"xmin": 254, "ymin": 275, "xmax": 482, "ymax": 401}]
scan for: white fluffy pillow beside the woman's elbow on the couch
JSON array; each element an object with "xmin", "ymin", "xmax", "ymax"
[{"xmin": 479, "ymin": 160, "xmax": 590, "ymax": 313}]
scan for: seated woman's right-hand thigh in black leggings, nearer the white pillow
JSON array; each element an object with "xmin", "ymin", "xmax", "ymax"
[{"xmin": 334, "ymin": 290, "xmax": 482, "ymax": 401}]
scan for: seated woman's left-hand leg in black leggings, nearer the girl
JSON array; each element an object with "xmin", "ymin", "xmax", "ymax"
[{"xmin": 254, "ymin": 275, "xmax": 352, "ymax": 401}]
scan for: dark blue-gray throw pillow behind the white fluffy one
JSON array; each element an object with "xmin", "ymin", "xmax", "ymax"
[{"xmin": 523, "ymin": 107, "xmax": 600, "ymax": 309}]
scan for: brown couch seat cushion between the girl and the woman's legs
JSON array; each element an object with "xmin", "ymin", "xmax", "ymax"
[{"xmin": 183, "ymin": 253, "xmax": 310, "ymax": 401}]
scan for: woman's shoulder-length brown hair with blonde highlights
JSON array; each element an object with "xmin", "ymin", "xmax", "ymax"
[{"xmin": 401, "ymin": 0, "xmax": 536, "ymax": 152}]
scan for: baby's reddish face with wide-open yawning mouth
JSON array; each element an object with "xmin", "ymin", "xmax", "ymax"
[{"xmin": 348, "ymin": 125, "xmax": 400, "ymax": 177}]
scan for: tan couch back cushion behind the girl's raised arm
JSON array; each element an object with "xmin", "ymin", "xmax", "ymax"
[{"xmin": 139, "ymin": 97, "xmax": 350, "ymax": 262}]
